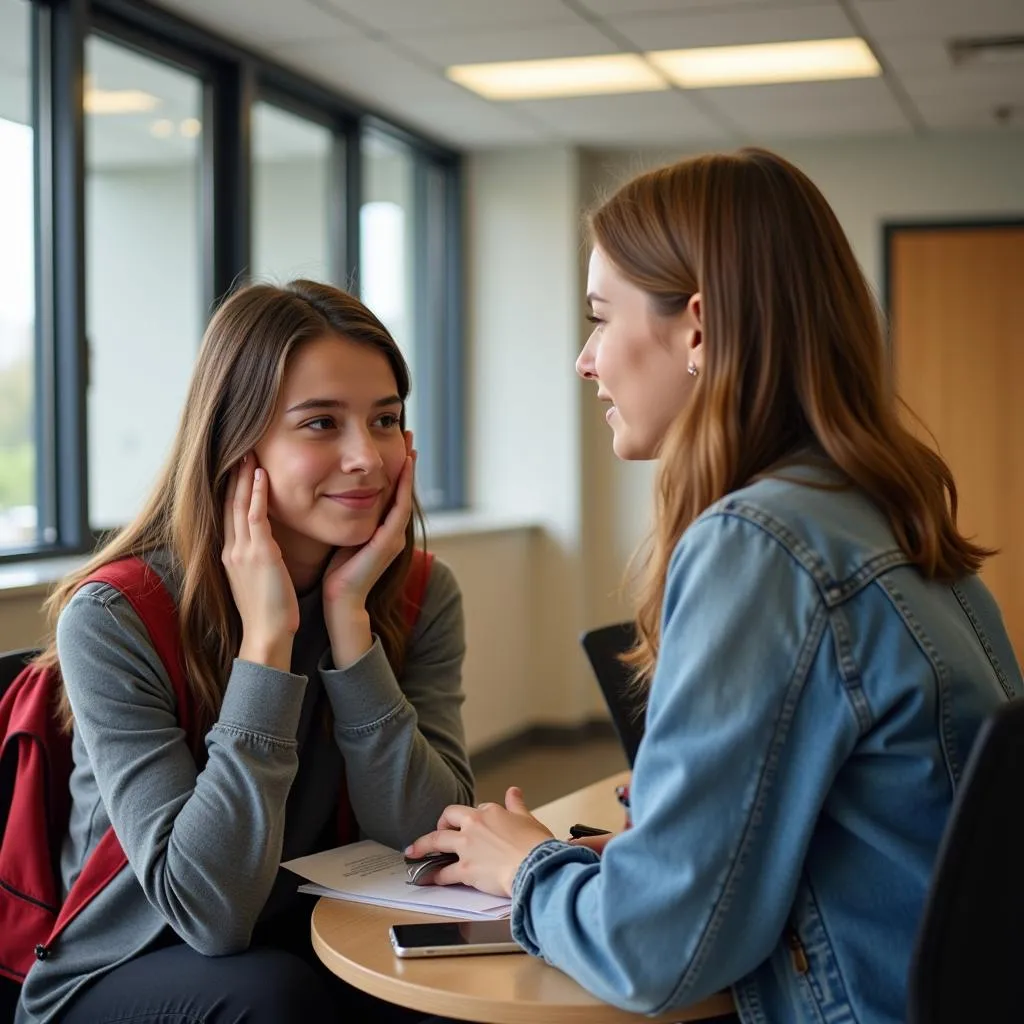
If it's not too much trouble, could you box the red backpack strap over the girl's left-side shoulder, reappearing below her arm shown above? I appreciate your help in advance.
[44,558,196,955]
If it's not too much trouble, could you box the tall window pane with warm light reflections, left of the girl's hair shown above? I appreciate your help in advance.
[85,37,205,529]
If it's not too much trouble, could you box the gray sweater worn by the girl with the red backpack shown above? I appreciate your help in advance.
[15,557,473,1024]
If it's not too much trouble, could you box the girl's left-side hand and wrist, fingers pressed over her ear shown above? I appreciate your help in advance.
[221,453,299,672]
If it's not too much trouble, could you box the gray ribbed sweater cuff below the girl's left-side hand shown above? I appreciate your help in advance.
[217,658,307,743]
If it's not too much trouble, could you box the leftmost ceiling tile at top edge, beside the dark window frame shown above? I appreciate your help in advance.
[149,0,358,47]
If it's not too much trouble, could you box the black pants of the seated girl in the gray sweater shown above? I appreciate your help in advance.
[60,899,432,1024]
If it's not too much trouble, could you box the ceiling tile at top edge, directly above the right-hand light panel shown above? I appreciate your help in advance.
[607,3,854,50]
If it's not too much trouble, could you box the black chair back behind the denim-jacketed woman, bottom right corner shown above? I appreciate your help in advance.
[908,699,1024,1024]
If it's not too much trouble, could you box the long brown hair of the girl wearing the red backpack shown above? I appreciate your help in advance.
[38,281,423,734]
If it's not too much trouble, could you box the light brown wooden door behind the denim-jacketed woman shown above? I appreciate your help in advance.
[889,225,1024,663]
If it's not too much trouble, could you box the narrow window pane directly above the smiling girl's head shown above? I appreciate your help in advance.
[252,102,335,284]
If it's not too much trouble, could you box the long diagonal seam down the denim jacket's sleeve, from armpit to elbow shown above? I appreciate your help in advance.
[655,603,828,1013]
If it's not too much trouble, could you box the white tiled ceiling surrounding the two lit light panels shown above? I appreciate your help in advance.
[155,0,1024,146]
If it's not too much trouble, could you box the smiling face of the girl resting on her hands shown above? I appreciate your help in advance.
[256,335,411,568]
